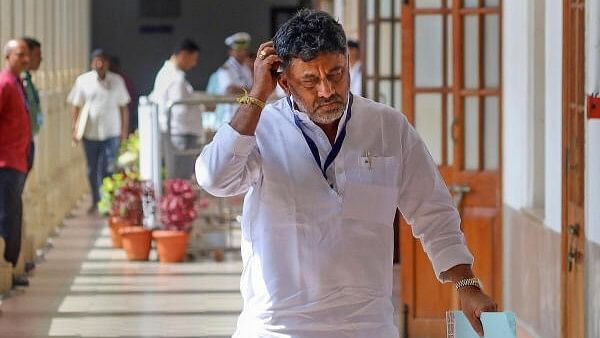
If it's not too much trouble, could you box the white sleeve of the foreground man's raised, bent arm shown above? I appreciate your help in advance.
[196,124,261,197]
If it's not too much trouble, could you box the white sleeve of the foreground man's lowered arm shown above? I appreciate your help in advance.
[398,121,473,281]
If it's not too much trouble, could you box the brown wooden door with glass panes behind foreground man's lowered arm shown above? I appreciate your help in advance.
[400,0,502,337]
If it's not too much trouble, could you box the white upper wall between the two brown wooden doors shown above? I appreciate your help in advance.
[503,0,562,232]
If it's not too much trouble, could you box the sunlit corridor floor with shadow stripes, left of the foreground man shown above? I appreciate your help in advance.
[0,198,242,338]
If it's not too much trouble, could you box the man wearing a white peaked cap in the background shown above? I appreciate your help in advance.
[208,32,252,127]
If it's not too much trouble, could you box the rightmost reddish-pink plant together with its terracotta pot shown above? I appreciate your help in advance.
[152,179,197,262]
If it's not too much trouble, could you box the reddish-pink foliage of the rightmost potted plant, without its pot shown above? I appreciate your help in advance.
[158,179,198,231]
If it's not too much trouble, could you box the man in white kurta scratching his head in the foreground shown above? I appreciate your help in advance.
[196,10,496,338]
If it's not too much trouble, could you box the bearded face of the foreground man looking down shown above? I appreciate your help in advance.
[279,53,350,124]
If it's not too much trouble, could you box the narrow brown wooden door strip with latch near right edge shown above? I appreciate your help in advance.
[561,0,585,338]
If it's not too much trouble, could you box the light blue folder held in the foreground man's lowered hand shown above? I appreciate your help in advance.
[446,311,517,338]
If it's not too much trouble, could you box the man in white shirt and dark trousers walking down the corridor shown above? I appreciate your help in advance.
[67,49,131,213]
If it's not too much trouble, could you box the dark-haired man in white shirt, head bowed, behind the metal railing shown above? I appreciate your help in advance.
[150,39,203,179]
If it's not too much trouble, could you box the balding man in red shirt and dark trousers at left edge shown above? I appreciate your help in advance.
[0,40,31,286]
